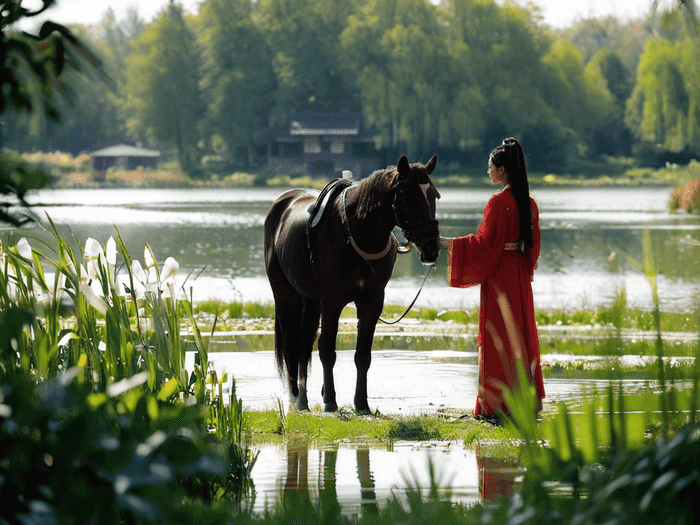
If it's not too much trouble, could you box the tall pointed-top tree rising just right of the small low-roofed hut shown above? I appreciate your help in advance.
[126,0,203,174]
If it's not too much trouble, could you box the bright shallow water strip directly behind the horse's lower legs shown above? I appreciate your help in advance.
[185,349,672,415]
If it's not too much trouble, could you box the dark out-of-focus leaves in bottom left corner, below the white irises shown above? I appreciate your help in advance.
[0,356,237,524]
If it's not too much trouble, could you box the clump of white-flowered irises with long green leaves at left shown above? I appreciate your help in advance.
[0,218,255,506]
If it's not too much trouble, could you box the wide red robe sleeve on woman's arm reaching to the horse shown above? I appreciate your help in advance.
[447,194,508,288]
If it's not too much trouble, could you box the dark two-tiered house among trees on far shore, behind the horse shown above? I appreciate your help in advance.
[255,111,379,178]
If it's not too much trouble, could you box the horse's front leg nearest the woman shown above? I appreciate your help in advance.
[355,293,384,414]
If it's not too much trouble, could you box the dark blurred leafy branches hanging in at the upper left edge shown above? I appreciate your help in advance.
[0,0,100,225]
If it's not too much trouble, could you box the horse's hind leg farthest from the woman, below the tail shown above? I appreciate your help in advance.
[273,283,309,410]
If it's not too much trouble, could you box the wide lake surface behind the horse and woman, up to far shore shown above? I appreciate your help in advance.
[3,187,700,310]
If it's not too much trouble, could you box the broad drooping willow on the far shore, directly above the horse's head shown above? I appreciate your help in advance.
[341,0,485,158]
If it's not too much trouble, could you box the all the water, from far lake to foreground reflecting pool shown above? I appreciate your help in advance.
[2,184,700,514]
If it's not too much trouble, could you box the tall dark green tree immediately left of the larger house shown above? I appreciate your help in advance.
[198,0,275,165]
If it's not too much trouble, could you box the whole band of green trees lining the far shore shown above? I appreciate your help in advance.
[3,0,700,173]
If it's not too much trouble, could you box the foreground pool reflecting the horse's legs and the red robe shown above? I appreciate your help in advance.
[250,439,524,515]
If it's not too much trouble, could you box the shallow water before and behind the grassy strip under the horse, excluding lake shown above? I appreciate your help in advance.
[194,349,676,515]
